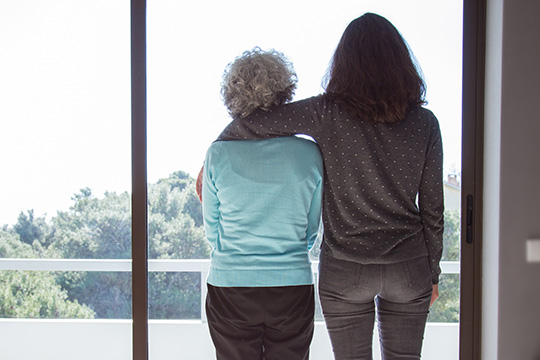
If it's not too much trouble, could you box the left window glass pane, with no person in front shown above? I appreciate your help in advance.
[0,0,131,360]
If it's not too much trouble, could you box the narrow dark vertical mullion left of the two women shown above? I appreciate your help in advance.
[131,0,148,360]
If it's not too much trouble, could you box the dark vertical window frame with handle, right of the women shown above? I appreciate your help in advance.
[459,0,486,360]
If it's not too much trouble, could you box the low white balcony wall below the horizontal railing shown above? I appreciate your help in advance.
[0,319,459,360]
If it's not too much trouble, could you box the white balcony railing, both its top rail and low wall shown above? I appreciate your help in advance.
[0,259,459,360]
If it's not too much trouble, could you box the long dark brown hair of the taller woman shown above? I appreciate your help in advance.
[325,13,426,122]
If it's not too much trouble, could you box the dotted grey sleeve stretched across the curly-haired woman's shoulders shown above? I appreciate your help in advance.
[218,96,327,140]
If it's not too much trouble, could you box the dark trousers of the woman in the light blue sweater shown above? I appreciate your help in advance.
[206,284,315,360]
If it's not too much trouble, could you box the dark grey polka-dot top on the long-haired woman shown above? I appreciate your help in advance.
[218,96,444,284]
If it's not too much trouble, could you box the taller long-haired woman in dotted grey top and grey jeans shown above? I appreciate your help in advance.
[211,13,443,360]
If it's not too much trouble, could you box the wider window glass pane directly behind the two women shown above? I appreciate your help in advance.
[148,0,462,360]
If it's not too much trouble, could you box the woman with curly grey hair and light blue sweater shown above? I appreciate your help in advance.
[202,49,323,360]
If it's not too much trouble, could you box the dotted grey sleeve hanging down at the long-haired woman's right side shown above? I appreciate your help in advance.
[418,115,444,284]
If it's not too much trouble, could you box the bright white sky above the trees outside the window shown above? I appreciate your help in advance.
[0,0,462,225]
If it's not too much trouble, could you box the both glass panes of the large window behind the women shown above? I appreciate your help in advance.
[0,0,482,360]
